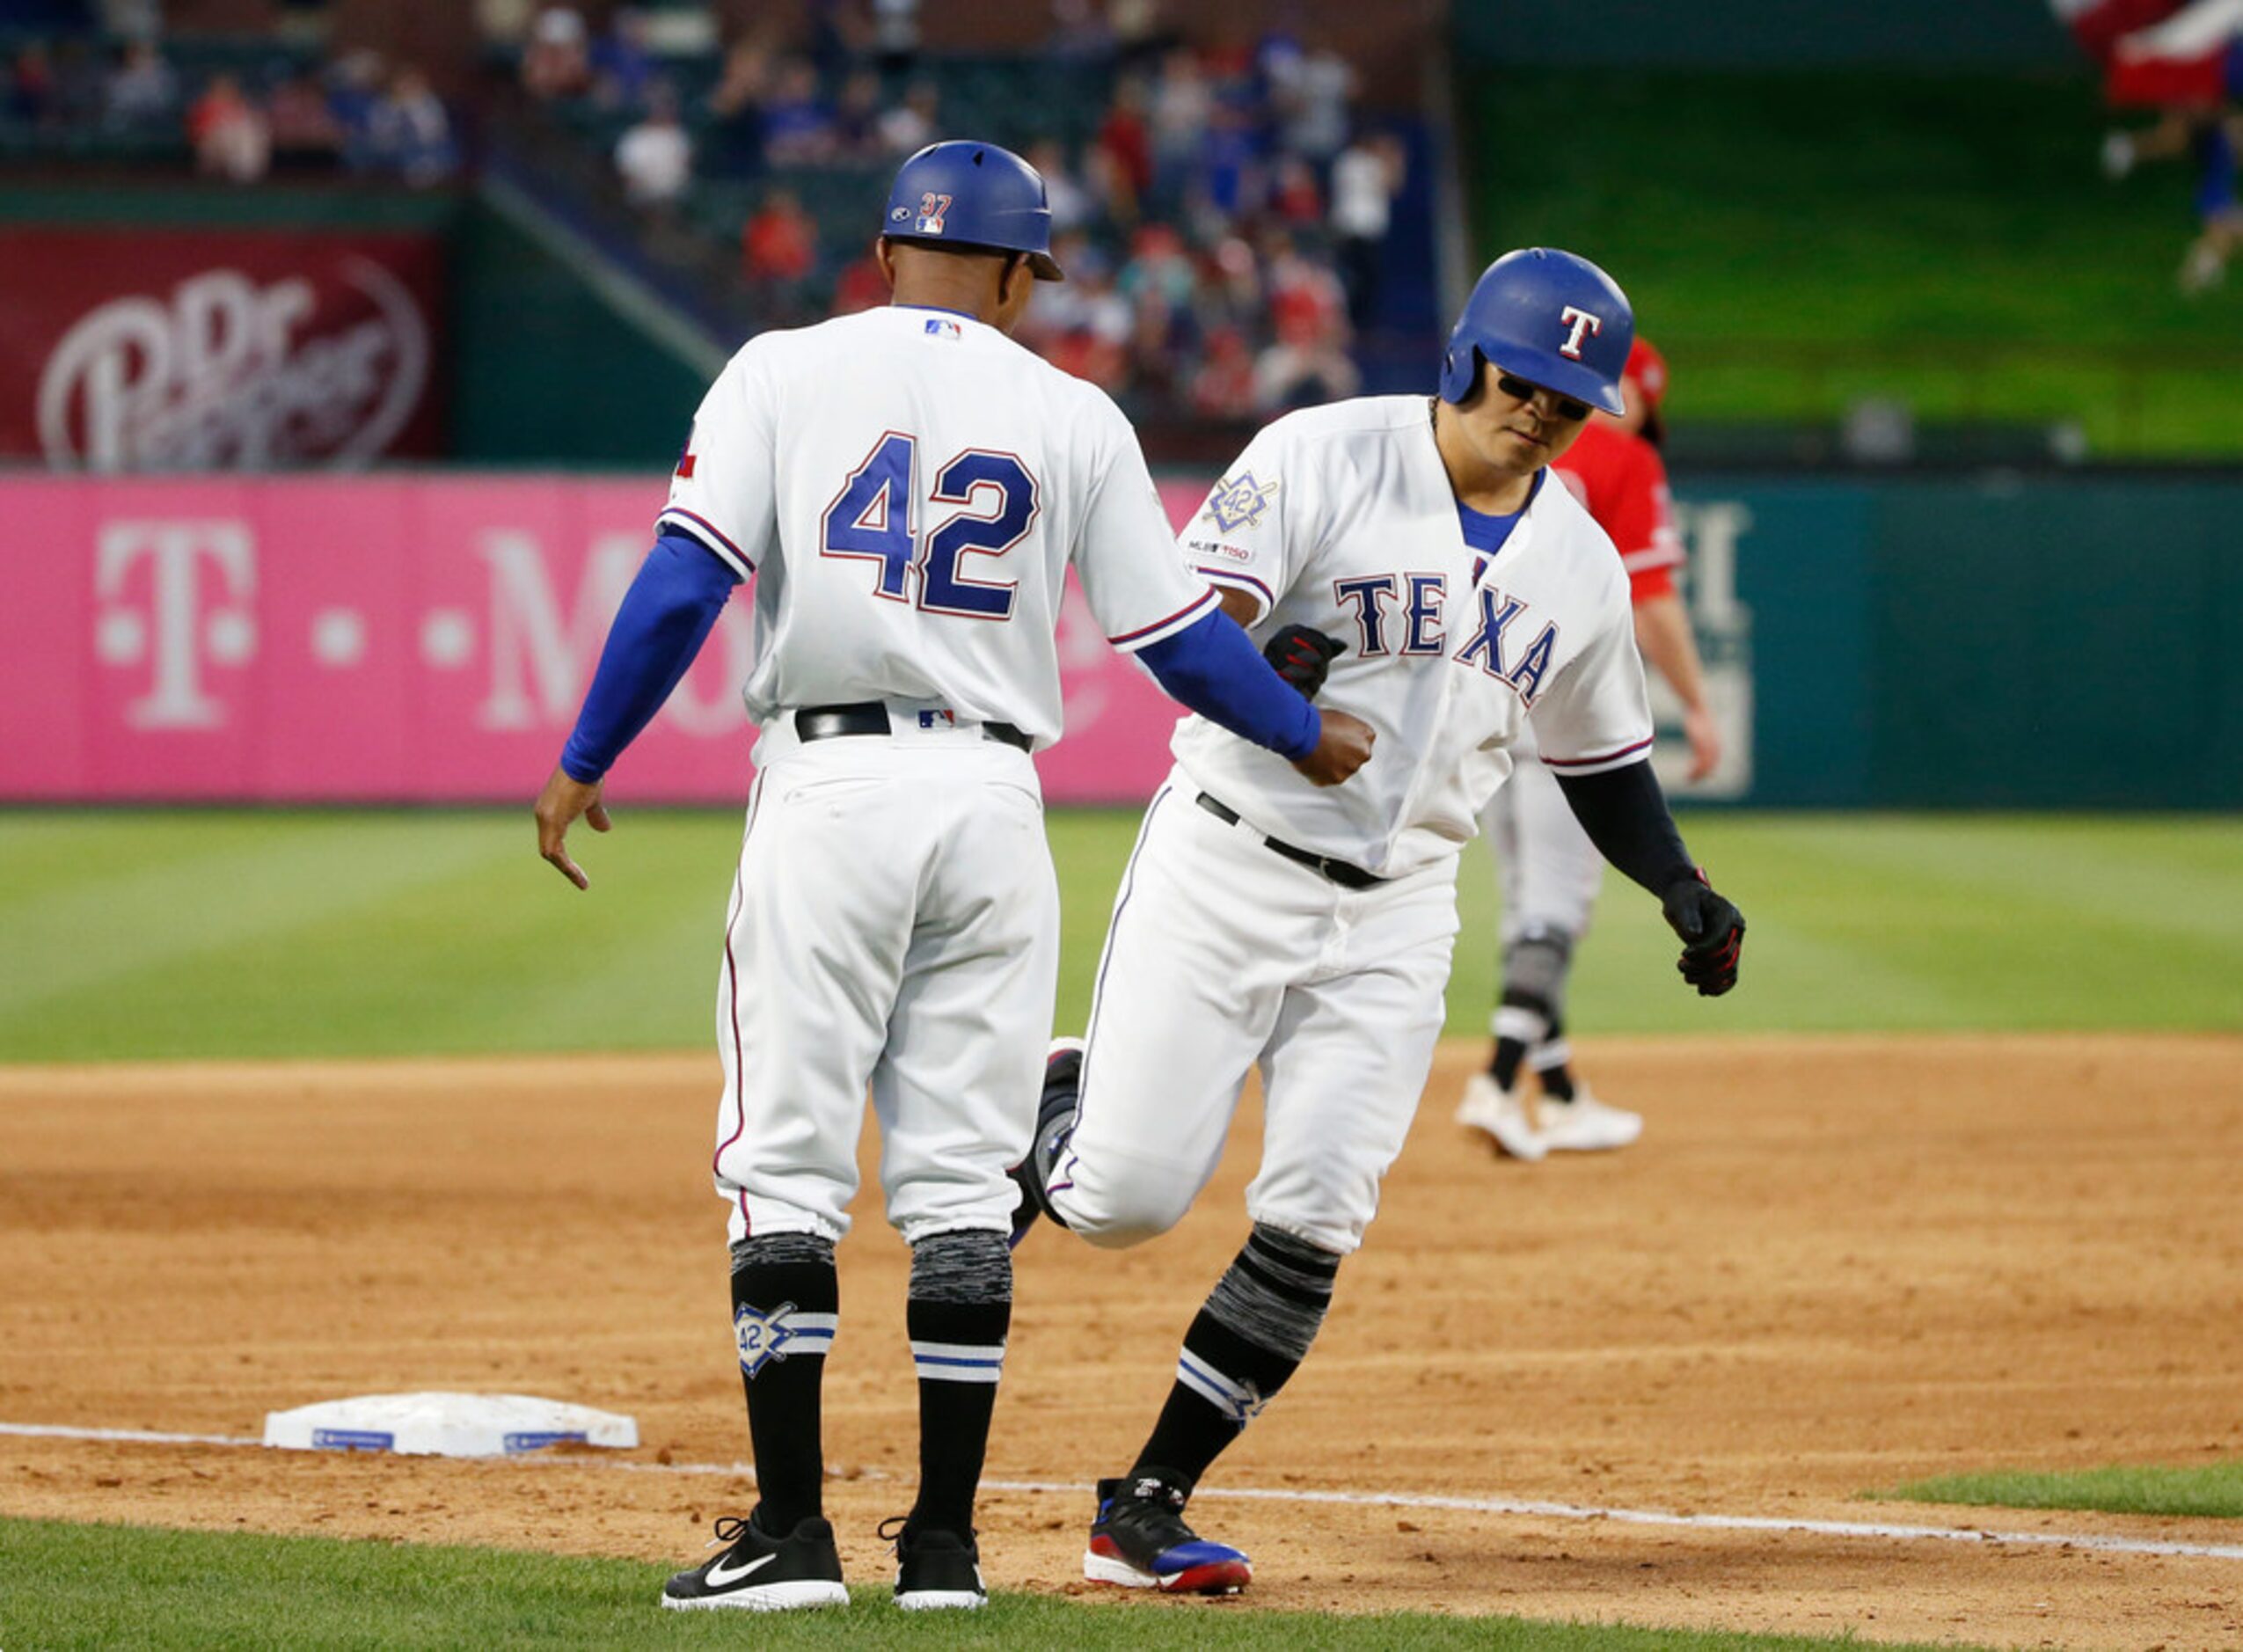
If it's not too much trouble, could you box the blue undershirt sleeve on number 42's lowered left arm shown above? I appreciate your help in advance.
[561,532,741,786]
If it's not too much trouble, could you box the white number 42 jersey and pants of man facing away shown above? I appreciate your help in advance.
[661,308,1216,1239]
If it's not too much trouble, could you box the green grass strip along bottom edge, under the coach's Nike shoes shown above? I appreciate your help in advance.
[0,1519,2000,1652]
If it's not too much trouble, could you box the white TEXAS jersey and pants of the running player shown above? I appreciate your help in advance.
[1049,398,1651,1254]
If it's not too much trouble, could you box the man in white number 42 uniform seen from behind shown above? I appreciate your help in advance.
[538,142,1373,1610]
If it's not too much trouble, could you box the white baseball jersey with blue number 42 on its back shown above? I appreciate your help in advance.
[660,305,1216,748]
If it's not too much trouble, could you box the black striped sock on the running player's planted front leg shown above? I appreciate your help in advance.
[1130,1224,1339,1495]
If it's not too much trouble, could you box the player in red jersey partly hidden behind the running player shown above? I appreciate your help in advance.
[1456,339,1721,1163]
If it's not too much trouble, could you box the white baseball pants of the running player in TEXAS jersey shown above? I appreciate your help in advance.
[1049,770,1458,1254]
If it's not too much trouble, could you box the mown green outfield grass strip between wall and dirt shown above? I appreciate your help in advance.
[0,810,2243,1062]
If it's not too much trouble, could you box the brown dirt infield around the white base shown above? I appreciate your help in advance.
[0,1037,2243,1652]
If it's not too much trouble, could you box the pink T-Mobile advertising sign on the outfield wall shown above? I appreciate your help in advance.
[0,476,1200,803]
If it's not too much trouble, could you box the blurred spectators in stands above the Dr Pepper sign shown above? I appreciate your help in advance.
[0,0,460,186]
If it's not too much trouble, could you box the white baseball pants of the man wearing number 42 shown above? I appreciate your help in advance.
[715,713,1059,1241]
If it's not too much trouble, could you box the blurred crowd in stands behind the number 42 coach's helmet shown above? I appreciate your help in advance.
[495,0,1406,420]
